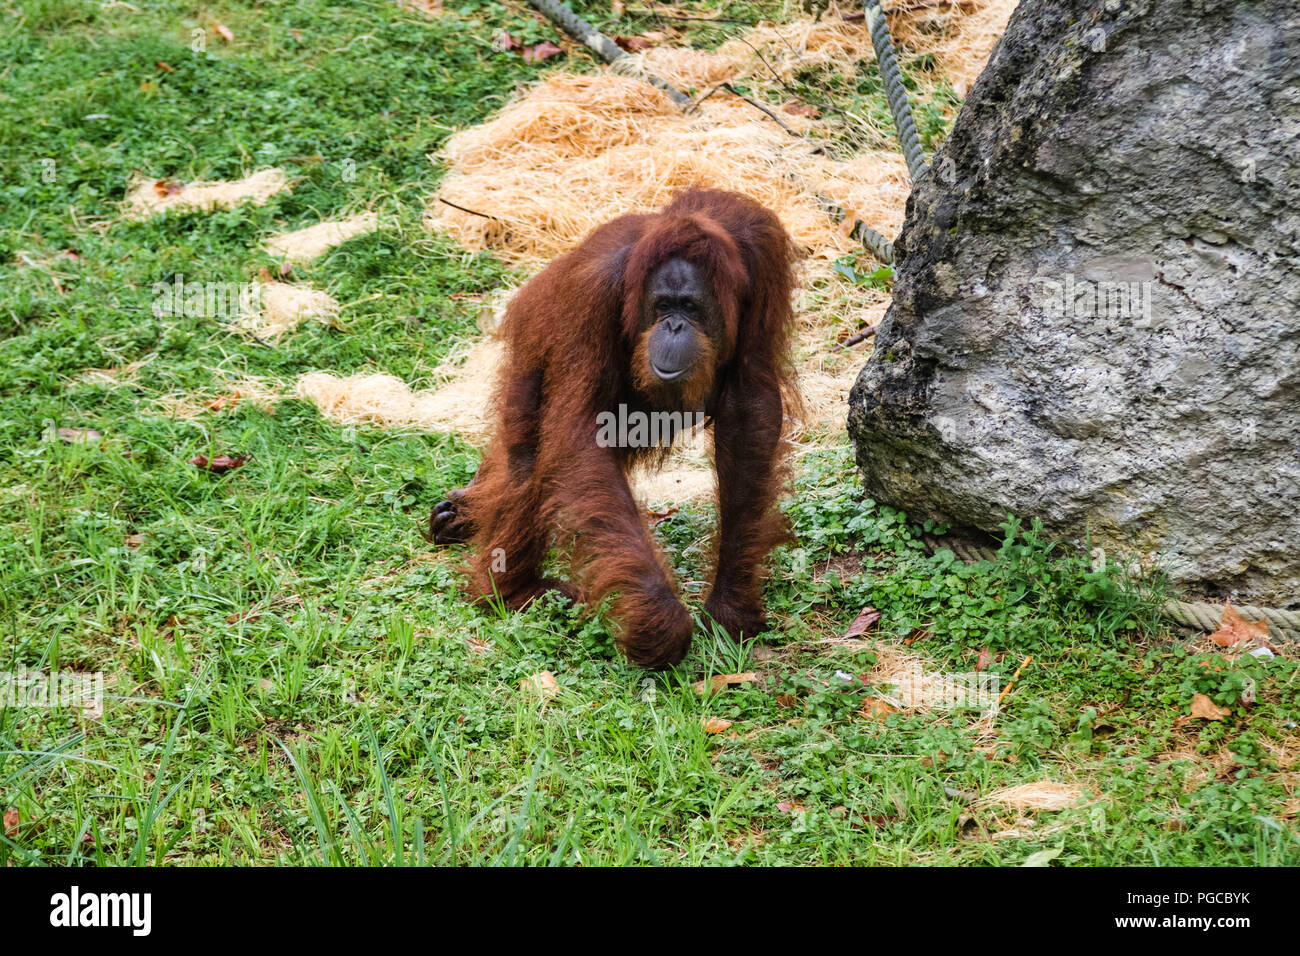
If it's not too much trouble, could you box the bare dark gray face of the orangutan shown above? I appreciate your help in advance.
[644,259,723,382]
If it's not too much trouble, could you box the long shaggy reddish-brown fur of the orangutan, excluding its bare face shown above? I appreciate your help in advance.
[436,190,798,667]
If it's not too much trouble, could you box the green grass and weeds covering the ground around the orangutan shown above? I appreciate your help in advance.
[0,0,1300,865]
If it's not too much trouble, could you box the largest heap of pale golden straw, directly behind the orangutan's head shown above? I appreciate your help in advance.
[426,74,907,265]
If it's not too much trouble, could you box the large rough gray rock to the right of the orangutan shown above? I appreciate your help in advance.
[849,0,1300,607]
